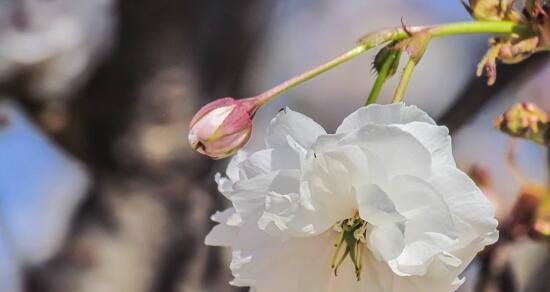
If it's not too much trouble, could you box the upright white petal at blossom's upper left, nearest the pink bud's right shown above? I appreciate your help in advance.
[265,108,326,151]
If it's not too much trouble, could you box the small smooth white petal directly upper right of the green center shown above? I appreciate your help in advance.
[355,184,406,225]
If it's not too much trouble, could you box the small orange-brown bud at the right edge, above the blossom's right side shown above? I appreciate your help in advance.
[495,102,550,144]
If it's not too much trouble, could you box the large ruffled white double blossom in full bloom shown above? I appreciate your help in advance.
[206,104,498,292]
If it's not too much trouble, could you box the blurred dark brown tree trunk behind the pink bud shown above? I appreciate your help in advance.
[24,0,273,292]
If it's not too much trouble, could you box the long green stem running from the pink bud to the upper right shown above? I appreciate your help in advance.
[256,21,532,104]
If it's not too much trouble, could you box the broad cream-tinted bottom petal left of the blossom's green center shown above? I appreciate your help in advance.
[231,229,336,292]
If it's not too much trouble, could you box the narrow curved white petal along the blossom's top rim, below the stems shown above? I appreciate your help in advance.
[336,103,435,134]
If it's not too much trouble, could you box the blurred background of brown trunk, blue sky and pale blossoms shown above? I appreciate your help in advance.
[0,0,550,292]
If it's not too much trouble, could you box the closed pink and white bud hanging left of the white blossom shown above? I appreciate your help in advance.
[189,97,260,159]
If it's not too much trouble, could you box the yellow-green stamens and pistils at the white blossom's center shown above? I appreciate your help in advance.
[331,212,367,281]
